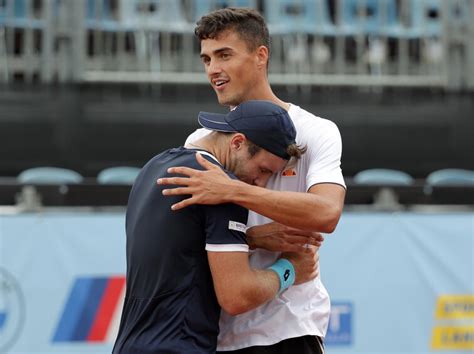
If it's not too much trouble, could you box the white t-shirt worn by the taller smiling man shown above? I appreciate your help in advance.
[186,105,345,351]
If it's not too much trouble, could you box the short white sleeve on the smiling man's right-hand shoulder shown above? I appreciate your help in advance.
[306,121,346,190]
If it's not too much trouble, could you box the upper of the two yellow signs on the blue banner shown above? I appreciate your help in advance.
[436,295,474,320]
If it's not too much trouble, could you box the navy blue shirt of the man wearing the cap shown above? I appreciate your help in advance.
[113,147,248,354]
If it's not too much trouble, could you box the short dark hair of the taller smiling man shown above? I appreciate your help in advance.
[194,7,270,53]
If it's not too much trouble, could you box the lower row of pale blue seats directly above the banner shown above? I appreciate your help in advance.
[0,166,474,210]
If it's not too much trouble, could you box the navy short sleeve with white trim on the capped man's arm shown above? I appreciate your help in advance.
[206,203,249,252]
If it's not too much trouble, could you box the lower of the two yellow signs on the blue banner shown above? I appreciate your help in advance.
[431,326,474,350]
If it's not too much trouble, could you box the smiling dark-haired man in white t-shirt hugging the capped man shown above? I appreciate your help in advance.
[158,8,345,354]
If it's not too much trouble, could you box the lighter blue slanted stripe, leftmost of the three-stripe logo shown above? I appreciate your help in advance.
[53,278,94,342]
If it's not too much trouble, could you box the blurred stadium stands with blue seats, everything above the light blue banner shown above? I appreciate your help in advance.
[0,0,474,206]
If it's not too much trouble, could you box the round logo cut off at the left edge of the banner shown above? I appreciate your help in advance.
[0,268,25,353]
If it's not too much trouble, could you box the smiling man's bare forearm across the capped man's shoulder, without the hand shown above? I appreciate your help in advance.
[226,181,342,233]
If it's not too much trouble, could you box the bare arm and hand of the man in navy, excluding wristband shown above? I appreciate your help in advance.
[207,248,319,315]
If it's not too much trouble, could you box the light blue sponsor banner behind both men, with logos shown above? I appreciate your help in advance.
[0,212,474,354]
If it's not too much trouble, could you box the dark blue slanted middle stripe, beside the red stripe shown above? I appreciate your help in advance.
[72,278,108,341]
